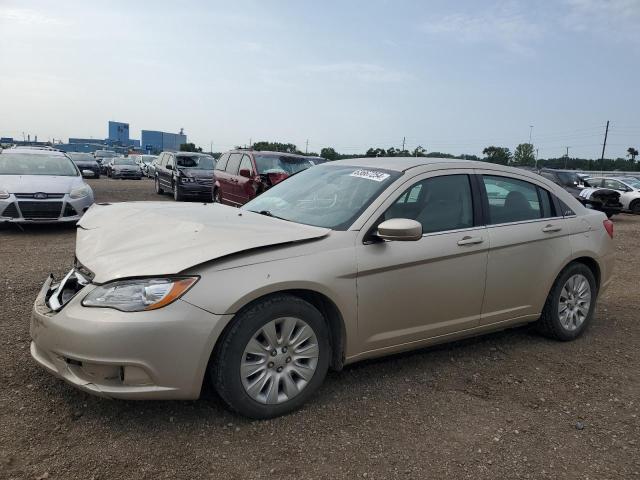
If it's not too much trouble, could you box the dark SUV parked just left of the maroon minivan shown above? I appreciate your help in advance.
[154,152,216,202]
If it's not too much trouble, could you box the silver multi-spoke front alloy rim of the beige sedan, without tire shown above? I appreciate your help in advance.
[240,317,320,405]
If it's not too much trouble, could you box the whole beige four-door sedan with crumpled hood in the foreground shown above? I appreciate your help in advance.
[31,158,614,418]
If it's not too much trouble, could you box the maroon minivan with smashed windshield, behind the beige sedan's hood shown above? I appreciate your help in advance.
[213,150,325,207]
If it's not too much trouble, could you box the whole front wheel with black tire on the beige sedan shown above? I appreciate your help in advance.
[209,295,330,419]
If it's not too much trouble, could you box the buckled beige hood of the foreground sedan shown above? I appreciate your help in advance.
[76,202,329,283]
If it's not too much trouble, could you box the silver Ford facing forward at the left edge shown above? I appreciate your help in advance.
[0,148,93,223]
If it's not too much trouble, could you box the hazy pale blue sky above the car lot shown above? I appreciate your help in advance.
[0,0,640,158]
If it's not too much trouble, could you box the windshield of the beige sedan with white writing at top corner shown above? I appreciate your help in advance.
[242,164,401,230]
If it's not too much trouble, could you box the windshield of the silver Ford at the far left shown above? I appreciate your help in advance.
[0,153,78,177]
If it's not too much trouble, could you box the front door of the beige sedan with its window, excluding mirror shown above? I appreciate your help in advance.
[356,170,489,351]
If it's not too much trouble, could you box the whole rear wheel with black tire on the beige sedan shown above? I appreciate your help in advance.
[537,263,598,341]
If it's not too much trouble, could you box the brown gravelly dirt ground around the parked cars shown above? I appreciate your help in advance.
[0,179,640,479]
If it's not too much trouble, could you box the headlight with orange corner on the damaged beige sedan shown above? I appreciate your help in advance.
[82,277,198,312]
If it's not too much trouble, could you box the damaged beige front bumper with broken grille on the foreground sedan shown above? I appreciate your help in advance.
[30,271,230,400]
